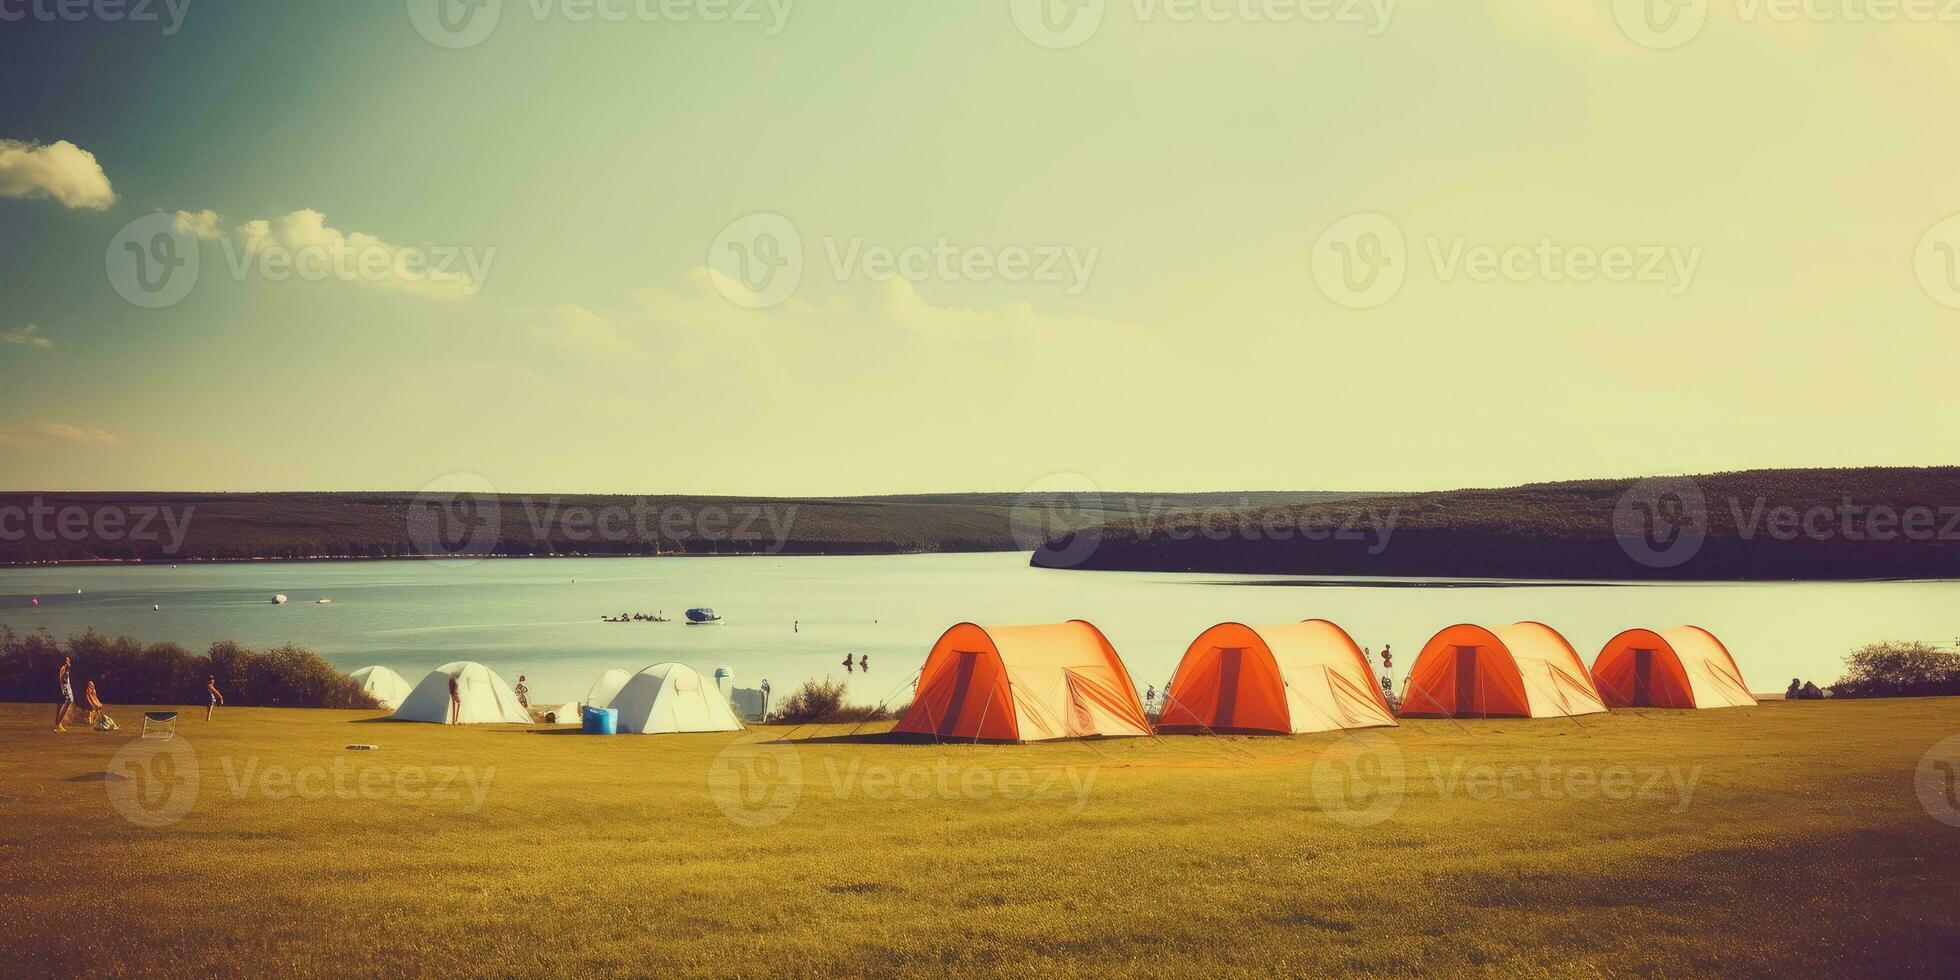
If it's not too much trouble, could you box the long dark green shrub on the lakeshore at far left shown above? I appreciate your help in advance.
[0,627,380,710]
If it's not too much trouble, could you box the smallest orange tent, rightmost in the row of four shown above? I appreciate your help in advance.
[1593,625,1756,708]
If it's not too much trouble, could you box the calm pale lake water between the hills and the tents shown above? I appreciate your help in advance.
[0,555,1960,704]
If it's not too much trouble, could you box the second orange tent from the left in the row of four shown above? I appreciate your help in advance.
[1156,619,1396,733]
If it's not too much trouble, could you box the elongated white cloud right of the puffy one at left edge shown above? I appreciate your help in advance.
[231,208,496,300]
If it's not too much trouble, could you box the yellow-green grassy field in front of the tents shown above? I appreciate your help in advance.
[0,700,1960,976]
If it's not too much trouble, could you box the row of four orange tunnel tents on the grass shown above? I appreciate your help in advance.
[894,619,1756,741]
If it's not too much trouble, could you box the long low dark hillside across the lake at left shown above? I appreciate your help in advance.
[0,492,1379,564]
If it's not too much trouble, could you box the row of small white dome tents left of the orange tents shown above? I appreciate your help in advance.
[380,662,743,735]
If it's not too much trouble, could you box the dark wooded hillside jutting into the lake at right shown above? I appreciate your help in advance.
[1035,466,1960,580]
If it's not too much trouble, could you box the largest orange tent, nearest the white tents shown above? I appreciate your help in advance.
[892,619,1151,741]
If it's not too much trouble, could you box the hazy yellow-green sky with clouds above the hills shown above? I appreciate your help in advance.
[0,0,1960,496]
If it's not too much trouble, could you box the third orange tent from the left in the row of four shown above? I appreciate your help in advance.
[1401,623,1605,717]
